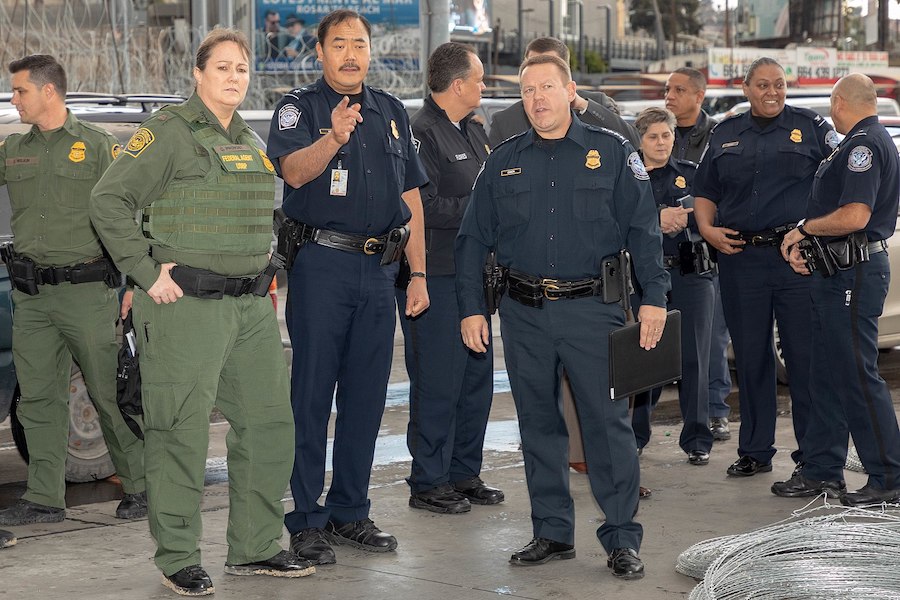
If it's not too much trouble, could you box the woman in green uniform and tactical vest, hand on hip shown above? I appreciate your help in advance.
[91,29,315,596]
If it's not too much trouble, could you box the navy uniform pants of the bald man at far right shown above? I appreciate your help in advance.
[803,252,900,489]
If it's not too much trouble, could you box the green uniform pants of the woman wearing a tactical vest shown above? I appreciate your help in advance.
[134,290,294,575]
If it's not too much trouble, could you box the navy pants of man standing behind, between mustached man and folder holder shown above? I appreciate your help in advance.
[397,275,494,493]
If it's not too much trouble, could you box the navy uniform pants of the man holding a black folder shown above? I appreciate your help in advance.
[500,297,643,552]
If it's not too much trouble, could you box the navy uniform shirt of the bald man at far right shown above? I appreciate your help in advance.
[807,116,900,241]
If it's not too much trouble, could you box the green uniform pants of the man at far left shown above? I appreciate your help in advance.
[13,282,144,508]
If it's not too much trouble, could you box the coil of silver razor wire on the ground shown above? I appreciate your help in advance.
[676,502,900,600]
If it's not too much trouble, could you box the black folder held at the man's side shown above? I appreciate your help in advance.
[609,310,681,400]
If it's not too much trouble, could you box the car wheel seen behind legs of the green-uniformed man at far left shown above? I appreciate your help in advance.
[10,364,116,483]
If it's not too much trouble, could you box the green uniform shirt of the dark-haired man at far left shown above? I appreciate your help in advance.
[0,112,120,267]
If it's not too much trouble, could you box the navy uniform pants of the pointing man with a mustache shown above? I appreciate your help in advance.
[285,244,398,533]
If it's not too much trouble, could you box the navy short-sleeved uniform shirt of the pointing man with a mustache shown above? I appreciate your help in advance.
[267,79,428,235]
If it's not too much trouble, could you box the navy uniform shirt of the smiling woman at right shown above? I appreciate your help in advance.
[694,105,838,231]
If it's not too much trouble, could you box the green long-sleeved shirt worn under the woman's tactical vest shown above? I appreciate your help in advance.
[91,93,275,290]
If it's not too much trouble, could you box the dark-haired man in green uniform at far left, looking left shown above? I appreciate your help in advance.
[0,55,147,525]
